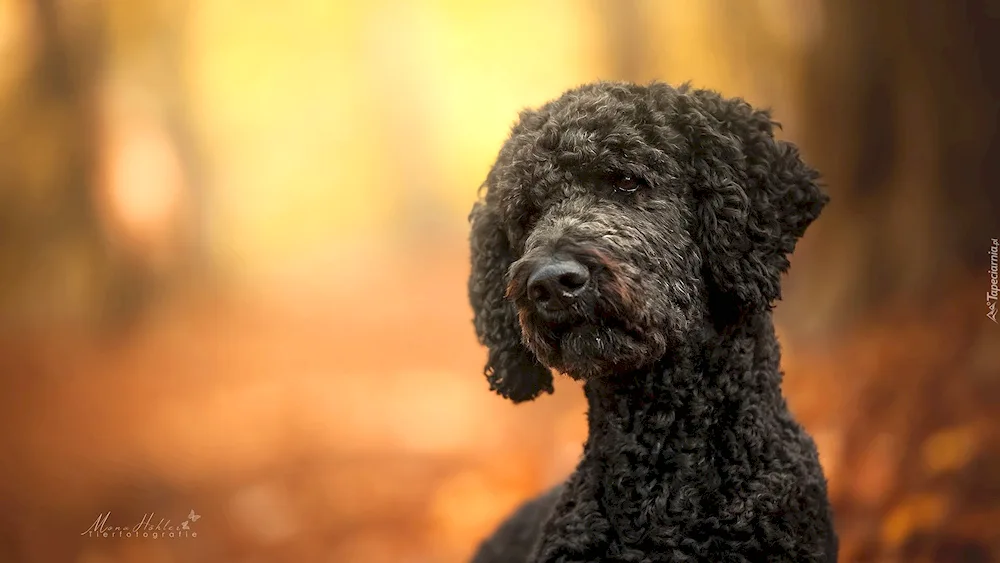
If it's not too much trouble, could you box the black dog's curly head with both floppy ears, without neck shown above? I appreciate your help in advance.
[469,83,827,401]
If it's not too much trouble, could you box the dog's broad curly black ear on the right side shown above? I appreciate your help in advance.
[678,86,829,315]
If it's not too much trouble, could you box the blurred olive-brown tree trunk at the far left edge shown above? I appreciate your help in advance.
[0,0,136,332]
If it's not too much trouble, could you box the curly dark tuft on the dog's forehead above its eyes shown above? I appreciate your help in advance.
[489,83,688,227]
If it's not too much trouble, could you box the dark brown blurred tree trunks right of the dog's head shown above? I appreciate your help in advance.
[796,0,1000,334]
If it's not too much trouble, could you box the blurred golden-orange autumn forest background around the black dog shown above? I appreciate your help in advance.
[0,0,1000,563]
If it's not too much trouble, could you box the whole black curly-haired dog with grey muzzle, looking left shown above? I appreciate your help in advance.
[469,82,837,563]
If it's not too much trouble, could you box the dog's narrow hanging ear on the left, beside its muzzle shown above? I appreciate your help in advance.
[469,187,552,403]
